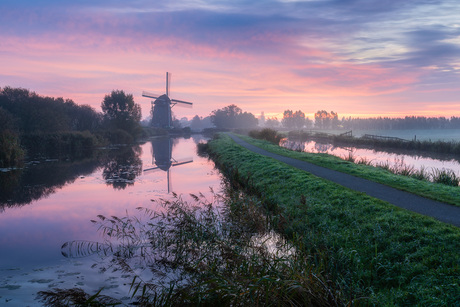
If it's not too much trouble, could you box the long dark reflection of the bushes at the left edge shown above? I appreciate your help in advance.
[0,159,99,211]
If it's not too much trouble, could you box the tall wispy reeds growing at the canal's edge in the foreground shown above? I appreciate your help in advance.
[45,183,344,306]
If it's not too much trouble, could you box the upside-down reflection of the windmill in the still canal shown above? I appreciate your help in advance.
[144,137,193,193]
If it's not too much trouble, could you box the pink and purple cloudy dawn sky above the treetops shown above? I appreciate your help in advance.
[0,0,460,119]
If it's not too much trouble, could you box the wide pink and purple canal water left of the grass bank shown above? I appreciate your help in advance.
[0,136,221,306]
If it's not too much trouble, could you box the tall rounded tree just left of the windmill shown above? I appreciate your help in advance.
[101,90,141,136]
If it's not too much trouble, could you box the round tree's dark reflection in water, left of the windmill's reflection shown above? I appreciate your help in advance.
[102,146,142,190]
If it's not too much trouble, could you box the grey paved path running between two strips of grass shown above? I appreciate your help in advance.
[228,134,460,227]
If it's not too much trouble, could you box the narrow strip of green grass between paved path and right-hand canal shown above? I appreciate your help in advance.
[239,135,460,206]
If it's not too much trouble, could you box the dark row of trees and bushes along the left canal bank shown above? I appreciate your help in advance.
[0,87,142,167]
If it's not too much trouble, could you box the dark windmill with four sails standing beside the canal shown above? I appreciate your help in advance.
[142,72,193,128]
